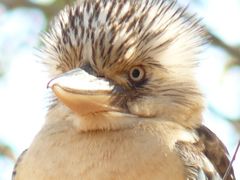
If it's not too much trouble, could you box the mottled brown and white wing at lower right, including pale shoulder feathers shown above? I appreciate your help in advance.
[175,126,236,180]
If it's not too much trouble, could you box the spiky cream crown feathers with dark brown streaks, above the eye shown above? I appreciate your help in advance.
[39,0,204,76]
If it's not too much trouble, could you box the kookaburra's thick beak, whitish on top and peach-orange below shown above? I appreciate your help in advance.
[48,68,117,116]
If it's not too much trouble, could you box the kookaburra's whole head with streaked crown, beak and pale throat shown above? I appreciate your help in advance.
[40,0,204,130]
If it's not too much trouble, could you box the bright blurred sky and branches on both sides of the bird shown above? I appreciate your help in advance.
[0,0,240,180]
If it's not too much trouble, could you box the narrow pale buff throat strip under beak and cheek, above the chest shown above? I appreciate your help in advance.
[46,103,202,131]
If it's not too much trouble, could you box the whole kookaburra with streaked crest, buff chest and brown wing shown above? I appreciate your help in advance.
[13,0,235,180]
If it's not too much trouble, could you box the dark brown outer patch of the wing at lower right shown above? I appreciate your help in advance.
[197,126,236,180]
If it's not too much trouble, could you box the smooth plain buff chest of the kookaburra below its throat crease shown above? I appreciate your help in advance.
[16,124,184,180]
